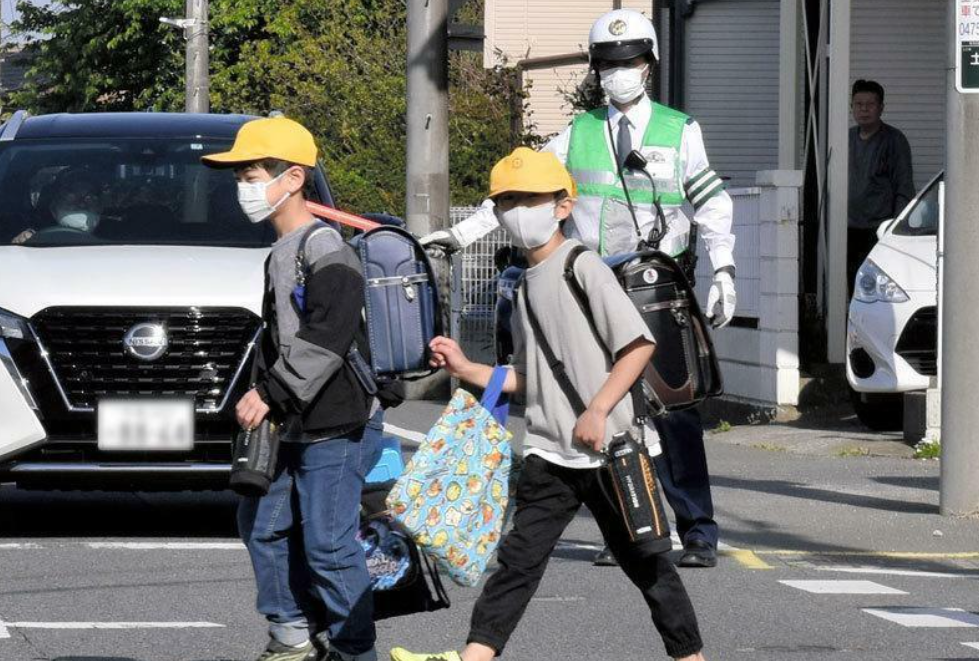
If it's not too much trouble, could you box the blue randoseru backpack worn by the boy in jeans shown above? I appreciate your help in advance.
[293,221,442,384]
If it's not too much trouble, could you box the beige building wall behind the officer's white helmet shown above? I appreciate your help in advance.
[483,0,652,136]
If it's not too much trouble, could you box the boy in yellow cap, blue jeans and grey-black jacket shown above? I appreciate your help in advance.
[203,117,381,661]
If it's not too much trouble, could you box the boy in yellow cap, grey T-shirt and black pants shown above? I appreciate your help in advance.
[391,148,704,661]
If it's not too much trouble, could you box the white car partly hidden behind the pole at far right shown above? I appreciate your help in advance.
[846,173,943,430]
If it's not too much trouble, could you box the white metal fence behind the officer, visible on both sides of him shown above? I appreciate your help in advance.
[450,188,761,364]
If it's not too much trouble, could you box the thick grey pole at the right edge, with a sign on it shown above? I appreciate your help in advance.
[941,0,979,516]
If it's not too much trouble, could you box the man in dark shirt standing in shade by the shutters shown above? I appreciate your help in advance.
[847,80,914,291]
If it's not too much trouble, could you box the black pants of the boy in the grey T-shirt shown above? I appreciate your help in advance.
[468,455,703,657]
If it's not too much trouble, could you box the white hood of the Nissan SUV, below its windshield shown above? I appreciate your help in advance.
[0,246,268,318]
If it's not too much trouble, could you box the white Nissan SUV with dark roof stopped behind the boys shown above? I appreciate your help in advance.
[0,112,333,489]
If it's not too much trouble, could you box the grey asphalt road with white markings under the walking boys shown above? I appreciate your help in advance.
[0,411,979,661]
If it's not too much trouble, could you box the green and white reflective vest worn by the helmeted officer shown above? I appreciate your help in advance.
[567,103,688,255]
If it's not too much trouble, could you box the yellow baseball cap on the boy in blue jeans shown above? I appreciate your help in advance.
[201,117,316,168]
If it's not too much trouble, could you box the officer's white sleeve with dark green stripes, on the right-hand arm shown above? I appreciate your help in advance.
[680,120,734,271]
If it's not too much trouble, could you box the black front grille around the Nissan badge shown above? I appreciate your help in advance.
[32,307,261,411]
